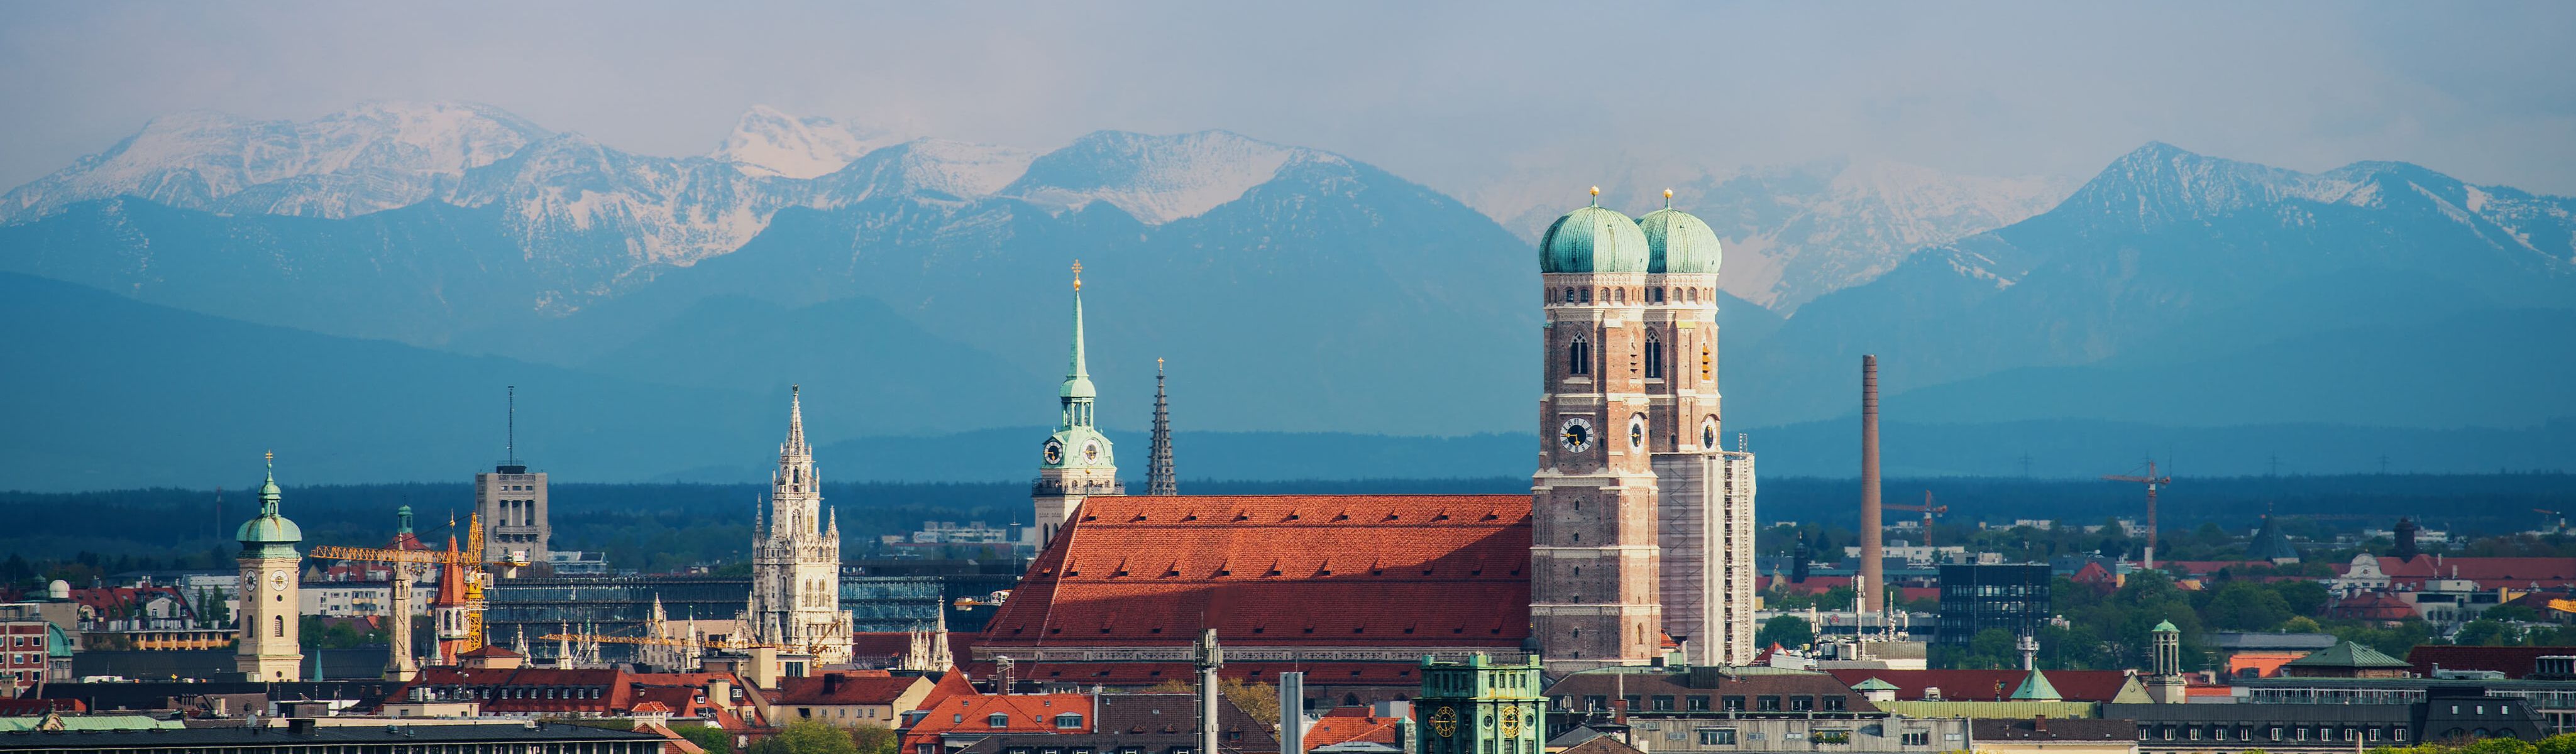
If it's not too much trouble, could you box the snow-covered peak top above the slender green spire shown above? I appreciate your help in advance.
[1002,131,1308,224]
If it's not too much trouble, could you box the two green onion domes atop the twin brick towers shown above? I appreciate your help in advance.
[1538,188,1724,275]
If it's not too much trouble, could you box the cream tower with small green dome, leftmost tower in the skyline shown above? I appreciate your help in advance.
[232,453,304,682]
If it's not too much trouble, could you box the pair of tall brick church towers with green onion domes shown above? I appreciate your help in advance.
[1530,190,1754,672]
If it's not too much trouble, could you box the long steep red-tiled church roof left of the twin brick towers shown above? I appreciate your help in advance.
[981,494,1530,646]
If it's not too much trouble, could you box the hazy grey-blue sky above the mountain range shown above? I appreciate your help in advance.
[0,3,2576,193]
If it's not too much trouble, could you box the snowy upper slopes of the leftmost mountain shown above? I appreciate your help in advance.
[0,103,546,224]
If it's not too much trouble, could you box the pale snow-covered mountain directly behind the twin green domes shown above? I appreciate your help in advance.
[1476,160,2074,314]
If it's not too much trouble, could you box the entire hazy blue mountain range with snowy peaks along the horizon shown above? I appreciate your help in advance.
[0,103,2576,489]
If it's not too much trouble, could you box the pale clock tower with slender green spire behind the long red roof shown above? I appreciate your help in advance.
[1030,263,1126,550]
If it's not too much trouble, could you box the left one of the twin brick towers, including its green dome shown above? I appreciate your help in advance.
[1530,188,1672,672]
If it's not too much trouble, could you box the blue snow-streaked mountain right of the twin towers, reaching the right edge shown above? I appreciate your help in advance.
[1729,144,2576,420]
